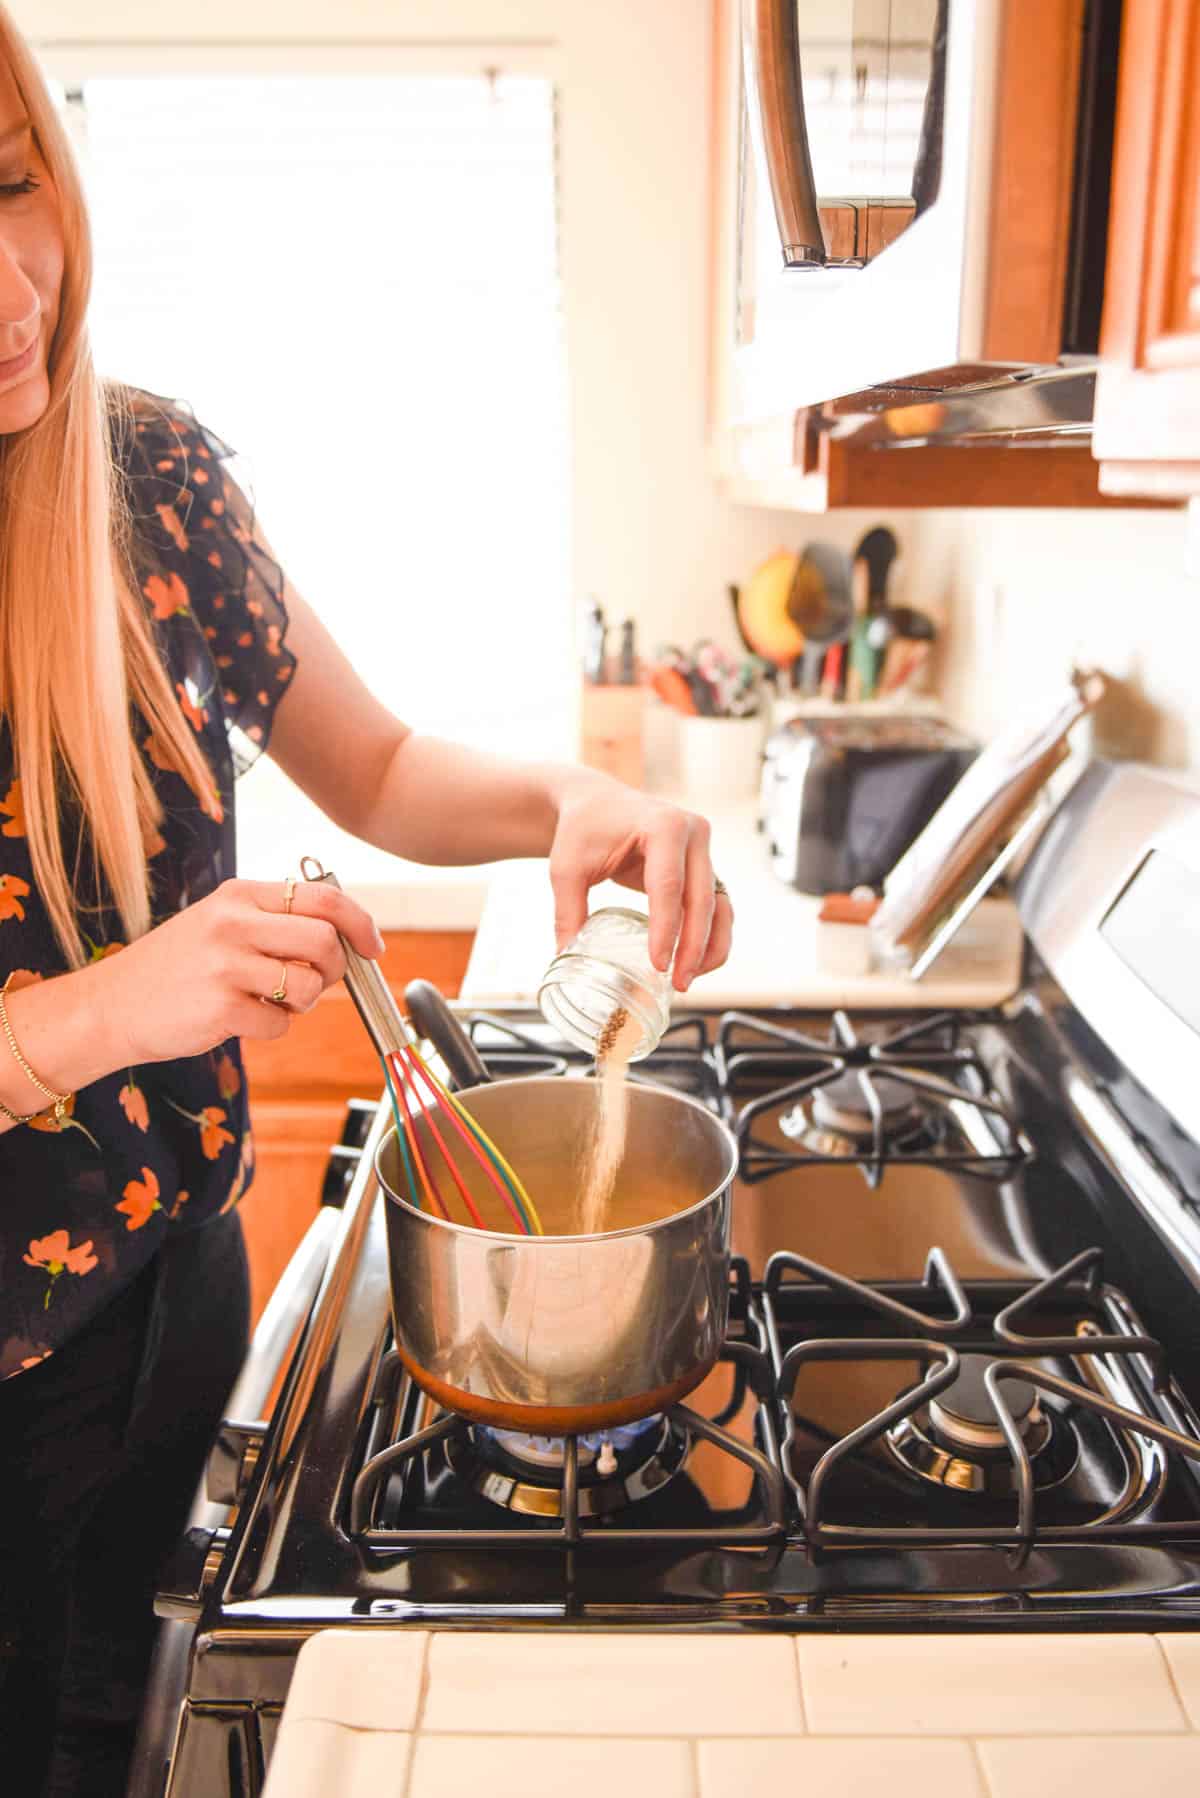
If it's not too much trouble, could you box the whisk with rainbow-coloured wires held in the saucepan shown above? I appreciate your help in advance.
[300,856,543,1235]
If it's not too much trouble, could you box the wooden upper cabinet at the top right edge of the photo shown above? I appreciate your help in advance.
[1092,0,1200,498]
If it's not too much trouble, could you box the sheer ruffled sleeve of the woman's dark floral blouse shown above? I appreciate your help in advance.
[127,403,295,773]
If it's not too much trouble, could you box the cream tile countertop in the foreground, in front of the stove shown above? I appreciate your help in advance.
[264,1627,1200,1798]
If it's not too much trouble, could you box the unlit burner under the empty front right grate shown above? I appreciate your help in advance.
[887,1354,1078,1496]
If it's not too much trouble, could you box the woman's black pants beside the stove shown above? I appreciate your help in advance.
[0,1212,248,1798]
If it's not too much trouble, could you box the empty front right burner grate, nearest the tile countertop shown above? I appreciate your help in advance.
[761,1248,1200,1568]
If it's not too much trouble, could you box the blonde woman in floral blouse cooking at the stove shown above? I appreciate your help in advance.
[0,11,730,1793]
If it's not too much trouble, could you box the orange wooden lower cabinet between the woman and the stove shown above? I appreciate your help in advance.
[233,930,473,1320]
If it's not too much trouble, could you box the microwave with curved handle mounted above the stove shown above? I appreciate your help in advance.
[723,0,1088,421]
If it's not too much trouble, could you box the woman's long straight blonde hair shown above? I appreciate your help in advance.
[0,5,214,967]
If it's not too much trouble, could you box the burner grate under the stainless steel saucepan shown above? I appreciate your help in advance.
[349,1257,788,1552]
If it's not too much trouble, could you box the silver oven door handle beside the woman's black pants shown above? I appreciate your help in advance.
[205,1205,342,1505]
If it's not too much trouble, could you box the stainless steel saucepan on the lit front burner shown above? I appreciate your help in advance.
[376,985,738,1437]
